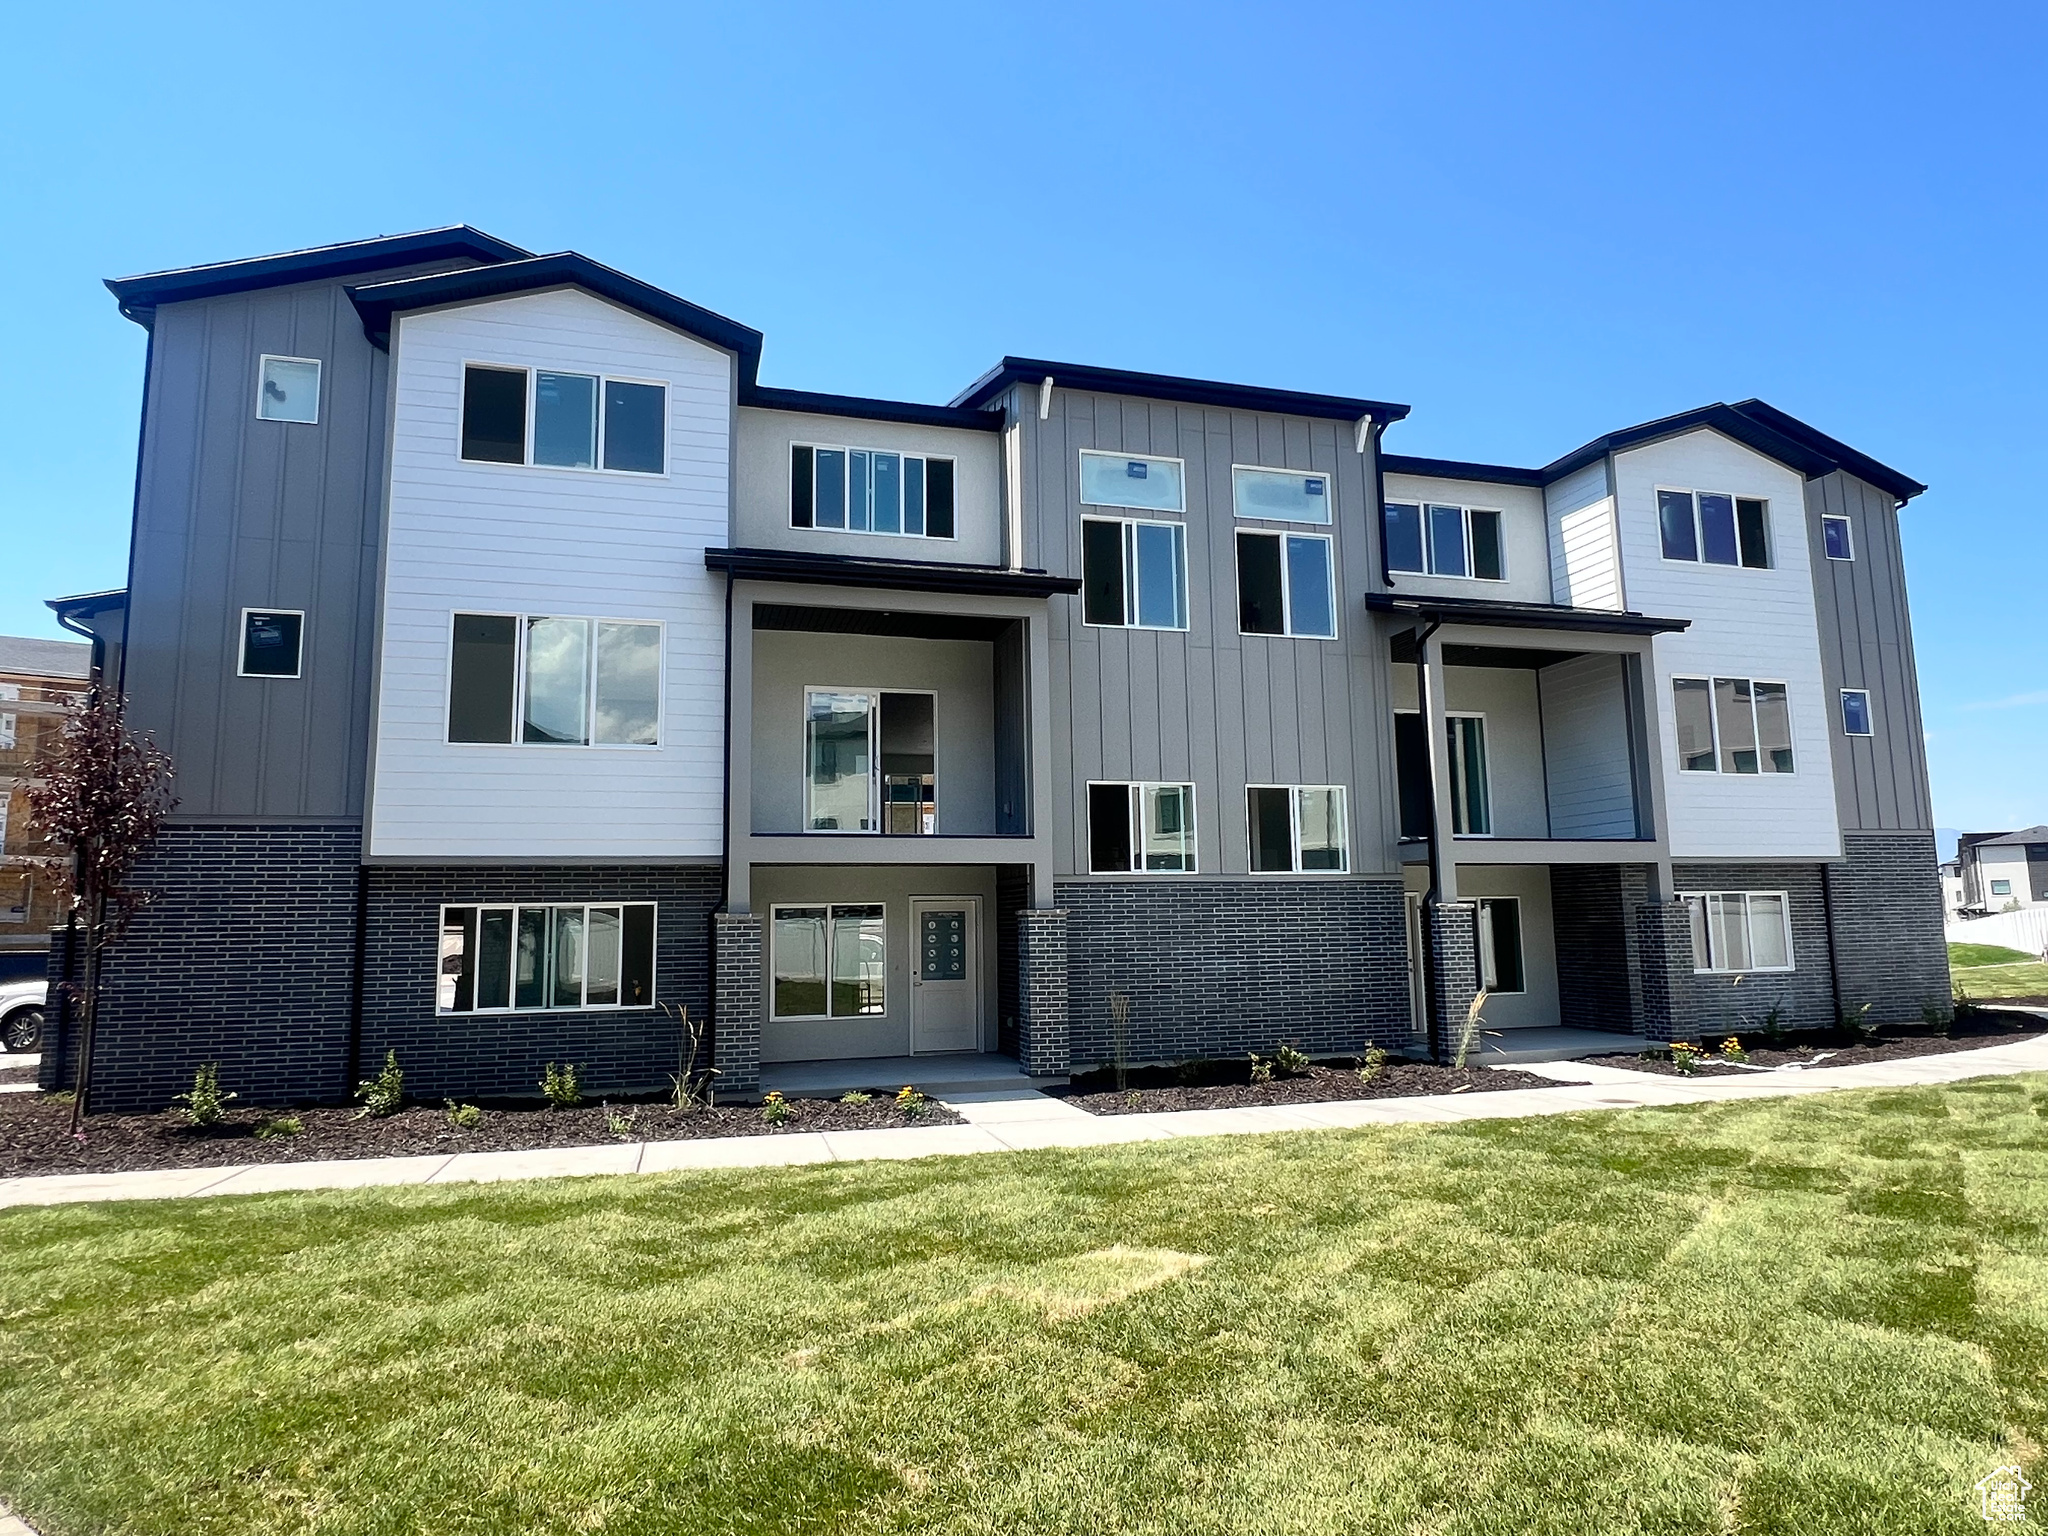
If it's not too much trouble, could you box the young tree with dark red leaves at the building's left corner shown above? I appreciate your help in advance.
[29,688,178,1137]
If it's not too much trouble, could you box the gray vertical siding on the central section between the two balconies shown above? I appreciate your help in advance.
[1008,385,1397,879]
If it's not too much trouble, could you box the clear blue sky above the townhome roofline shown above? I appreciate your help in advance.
[0,0,2048,827]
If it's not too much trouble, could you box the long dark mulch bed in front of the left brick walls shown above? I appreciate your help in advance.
[0,1094,958,1178]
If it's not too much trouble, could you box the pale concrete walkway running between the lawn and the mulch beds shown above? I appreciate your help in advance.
[0,1036,2048,1206]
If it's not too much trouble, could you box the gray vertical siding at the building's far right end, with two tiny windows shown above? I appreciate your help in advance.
[1806,469,1933,831]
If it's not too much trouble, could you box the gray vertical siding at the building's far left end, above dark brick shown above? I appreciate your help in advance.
[123,260,491,821]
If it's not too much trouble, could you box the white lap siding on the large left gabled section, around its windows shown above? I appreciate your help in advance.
[369,291,733,860]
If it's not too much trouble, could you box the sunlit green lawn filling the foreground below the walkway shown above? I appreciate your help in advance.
[0,1075,2048,1536]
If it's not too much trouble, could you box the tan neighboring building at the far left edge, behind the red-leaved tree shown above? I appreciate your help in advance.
[0,635,92,975]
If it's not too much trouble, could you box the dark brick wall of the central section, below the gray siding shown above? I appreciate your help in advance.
[1055,879,1411,1071]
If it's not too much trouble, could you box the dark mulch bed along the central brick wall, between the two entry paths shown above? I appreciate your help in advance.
[1044,1059,1559,1114]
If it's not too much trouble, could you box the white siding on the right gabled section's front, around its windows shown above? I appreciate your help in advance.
[1614,428,1841,858]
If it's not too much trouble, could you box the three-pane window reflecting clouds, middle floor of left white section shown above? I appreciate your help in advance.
[449,612,662,748]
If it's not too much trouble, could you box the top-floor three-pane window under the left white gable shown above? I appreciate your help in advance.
[463,362,668,475]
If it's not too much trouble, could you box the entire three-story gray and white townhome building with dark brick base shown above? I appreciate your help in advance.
[45,227,1948,1106]
